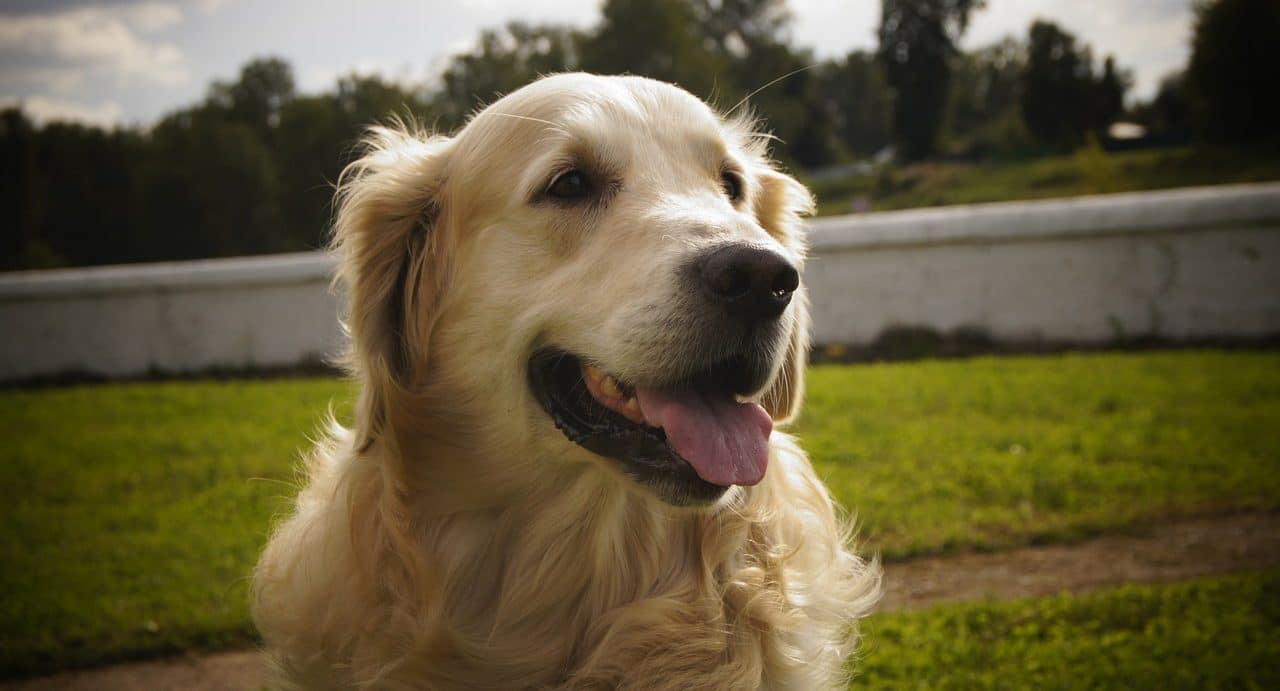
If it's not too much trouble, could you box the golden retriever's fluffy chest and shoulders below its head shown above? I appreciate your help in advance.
[255,434,878,690]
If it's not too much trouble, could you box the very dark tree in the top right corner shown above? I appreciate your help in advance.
[1187,0,1280,141]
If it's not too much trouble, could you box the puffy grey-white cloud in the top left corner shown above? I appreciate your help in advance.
[0,3,189,93]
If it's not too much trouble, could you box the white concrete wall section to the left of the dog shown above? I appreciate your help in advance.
[0,252,340,380]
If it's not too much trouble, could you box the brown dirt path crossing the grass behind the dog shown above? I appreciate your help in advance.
[10,513,1280,691]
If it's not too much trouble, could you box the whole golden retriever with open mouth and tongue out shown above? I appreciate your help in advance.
[253,74,879,691]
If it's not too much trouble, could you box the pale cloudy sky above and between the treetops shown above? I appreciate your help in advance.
[0,0,1192,124]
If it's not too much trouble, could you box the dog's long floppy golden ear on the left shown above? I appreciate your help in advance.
[330,127,449,448]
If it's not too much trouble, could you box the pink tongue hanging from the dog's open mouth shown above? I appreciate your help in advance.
[636,386,773,486]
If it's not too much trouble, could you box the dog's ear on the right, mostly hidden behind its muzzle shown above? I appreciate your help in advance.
[754,169,814,424]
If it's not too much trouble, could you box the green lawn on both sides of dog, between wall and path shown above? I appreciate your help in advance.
[0,352,1280,674]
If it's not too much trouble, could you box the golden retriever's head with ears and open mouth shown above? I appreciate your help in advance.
[335,74,813,504]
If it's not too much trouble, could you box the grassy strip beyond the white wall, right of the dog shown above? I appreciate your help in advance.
[806,143,1280,215]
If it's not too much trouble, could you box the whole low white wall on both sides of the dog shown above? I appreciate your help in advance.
[0,183,1280,380]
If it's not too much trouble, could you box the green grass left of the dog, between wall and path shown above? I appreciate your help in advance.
[0,380,349,673]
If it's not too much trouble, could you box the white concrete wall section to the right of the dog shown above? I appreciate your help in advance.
[805,183,1280,344]
